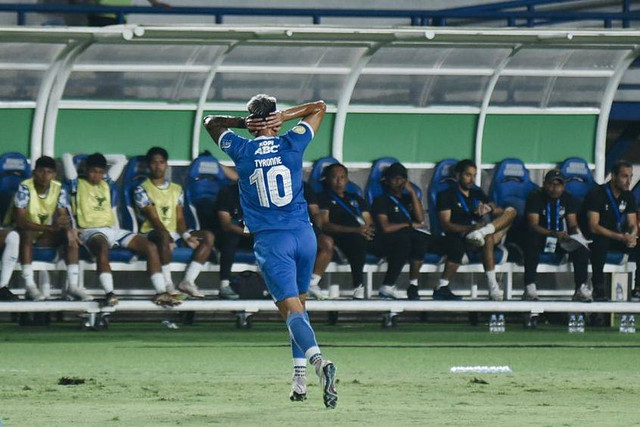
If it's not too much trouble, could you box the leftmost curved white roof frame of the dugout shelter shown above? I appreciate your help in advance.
[30,41,82,164]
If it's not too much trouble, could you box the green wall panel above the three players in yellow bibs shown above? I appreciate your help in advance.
[55,109,193,160]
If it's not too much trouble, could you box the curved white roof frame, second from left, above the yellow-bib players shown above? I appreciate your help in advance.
[42,40,92,157]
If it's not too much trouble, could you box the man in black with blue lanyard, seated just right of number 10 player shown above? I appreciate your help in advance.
[318,163,375,299]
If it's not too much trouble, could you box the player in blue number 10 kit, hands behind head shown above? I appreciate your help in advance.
[204,95,338,408]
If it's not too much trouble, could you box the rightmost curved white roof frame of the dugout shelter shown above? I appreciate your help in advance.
[594,45,640,183]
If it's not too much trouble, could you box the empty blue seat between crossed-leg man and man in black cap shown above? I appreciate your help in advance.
[489,158,538,219]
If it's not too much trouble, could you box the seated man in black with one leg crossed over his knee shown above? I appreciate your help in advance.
[434,159,516,301]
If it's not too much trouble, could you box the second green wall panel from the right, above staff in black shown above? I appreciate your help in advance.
[344,113,478,162]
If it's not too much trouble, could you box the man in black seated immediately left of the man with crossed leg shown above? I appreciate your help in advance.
[372,163,464,300]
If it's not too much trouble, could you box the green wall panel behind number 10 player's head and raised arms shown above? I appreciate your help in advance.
[200,111,335,161]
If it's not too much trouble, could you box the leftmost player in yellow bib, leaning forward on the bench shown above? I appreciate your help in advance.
[13,156,84,301]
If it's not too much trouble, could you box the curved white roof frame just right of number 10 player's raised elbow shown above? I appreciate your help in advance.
[331,43,387,162]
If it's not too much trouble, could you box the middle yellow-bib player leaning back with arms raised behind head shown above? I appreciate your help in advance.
[65,153,180,306]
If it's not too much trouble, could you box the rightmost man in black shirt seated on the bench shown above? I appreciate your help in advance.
[582,160,640,300]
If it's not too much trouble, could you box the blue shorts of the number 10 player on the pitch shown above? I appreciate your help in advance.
[253,225,317,302]
